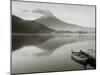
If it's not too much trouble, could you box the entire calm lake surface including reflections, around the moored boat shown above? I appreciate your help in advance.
[12,34,95,73]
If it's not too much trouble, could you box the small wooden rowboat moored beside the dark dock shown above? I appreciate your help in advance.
[71,51,88,69]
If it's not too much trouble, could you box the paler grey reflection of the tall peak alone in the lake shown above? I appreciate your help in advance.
[36,35,94,56]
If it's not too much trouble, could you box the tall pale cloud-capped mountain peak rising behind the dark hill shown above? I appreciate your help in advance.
[33,9,95,32]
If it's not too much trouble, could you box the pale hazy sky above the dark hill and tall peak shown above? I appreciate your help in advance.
[12,1,95,27]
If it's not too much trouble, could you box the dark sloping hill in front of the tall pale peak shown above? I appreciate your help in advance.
[12,15,54,33]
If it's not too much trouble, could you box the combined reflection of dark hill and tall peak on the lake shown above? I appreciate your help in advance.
[12,35,94,57]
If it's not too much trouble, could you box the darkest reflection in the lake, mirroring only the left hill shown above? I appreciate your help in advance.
[12,35,52,51]
